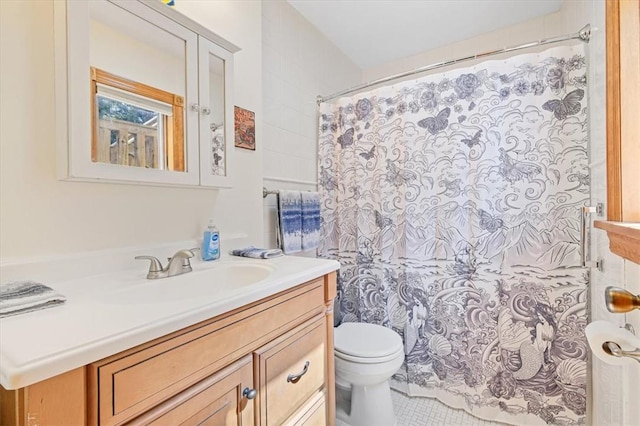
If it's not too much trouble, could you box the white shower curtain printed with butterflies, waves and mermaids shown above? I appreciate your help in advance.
[319,45,589,425]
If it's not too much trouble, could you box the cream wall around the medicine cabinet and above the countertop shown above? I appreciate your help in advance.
[0,0,263,260]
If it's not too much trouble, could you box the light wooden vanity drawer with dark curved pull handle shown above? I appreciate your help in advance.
[254,316,326,426]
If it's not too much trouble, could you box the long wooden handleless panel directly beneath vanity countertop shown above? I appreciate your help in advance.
[89,279,324,425]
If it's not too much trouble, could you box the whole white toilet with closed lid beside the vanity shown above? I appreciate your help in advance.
[333,322,404,426]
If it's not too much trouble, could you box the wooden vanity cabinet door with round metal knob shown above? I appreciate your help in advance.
[129,355,255,426]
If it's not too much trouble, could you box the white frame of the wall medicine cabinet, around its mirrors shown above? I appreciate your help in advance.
[53,0,240,188]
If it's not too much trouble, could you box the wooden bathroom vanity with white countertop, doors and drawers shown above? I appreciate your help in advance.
[0,257,338,425]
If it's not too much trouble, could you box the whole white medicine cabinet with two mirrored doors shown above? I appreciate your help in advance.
[54,0,239,188]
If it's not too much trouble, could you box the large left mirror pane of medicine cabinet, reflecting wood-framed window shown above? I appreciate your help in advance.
[89,2,186,171]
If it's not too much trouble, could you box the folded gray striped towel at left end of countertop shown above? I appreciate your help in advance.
[0,281,67,318]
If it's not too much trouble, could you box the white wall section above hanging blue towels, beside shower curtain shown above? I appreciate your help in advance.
[258,0,361,247]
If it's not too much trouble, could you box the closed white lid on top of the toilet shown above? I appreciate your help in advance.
[333,322,403,358]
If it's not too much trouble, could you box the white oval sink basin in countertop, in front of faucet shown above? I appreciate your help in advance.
[101,262,274,304]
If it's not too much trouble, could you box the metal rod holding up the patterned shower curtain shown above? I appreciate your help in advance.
[316,24,591,105]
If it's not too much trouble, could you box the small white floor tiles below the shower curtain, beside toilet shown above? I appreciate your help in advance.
[336,391,505,426]
